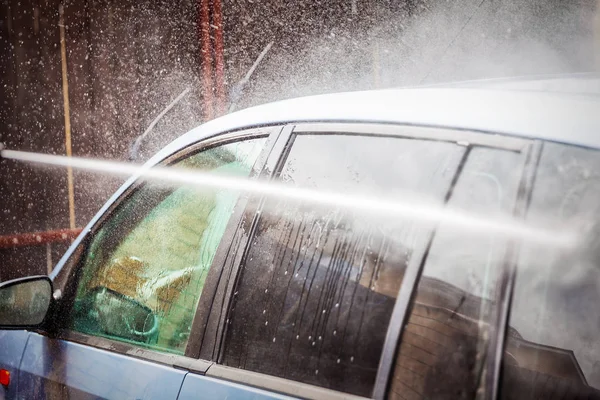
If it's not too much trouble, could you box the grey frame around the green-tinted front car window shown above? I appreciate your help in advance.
[45,125,283,373]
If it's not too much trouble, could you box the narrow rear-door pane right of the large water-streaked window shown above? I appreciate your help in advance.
[389,147,522,399]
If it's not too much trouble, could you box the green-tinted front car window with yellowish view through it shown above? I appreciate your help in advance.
[70,139,264,354]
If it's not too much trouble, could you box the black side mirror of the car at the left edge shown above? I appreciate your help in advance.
[0,276,52,329]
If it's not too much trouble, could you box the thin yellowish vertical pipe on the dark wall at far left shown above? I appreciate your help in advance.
[58,3,75,229]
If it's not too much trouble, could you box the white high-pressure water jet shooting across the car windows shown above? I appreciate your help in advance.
[0,149,580,251]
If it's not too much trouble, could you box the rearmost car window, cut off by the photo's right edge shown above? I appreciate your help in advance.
[501,143,600,399]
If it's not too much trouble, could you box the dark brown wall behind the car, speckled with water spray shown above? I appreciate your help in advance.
[0,0,600,280]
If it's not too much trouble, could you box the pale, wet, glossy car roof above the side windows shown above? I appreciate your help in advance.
[149,87,600,164]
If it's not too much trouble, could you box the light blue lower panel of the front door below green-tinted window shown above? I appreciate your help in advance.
[18,333,186,399]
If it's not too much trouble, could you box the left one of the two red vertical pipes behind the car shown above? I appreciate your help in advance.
[198,0,214,121]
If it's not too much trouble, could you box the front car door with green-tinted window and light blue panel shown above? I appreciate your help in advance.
[13,128,280,399]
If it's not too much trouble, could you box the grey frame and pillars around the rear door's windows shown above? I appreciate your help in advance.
[200,122,539,399]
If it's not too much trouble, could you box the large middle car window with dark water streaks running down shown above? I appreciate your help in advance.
[222,134,465,395]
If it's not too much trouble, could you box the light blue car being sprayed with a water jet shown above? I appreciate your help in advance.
[0,83,600,400]
